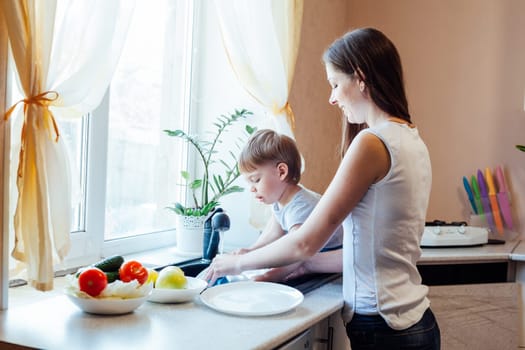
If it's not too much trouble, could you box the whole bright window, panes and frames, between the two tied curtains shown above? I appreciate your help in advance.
[8,0,259,269]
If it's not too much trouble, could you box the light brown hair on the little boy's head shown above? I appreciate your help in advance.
[239,129,301,184]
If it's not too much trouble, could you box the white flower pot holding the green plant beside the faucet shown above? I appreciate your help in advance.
[175,215,207,255]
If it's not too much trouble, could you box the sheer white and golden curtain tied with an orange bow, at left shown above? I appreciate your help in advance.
[0,0,135,290]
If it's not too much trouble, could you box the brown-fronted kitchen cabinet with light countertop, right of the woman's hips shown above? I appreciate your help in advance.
[418,242,522,350]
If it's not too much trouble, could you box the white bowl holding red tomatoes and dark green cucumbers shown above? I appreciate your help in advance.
[64,256,153,315]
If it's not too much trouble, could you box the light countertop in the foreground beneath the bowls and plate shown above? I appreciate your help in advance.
[0,280,343,350]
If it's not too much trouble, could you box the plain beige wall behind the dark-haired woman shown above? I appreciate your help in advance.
[291,0,525,238]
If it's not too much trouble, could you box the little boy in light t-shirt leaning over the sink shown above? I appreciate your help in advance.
[237,129,343,254]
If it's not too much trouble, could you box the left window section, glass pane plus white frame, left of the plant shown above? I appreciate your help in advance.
[9,0,193,268]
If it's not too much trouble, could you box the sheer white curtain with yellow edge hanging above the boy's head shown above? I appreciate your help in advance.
[215,0,303,137]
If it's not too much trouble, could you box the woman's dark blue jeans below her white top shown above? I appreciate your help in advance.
[346,309,441,350]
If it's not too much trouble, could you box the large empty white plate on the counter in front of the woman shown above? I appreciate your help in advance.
[200,281,304,316]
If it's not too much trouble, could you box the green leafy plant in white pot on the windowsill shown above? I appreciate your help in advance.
[164,109,255,254]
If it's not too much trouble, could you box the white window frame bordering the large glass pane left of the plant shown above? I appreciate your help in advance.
[56,1,200,270]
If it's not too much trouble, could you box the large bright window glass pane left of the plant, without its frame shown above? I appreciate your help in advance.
[104,0,191,240]
